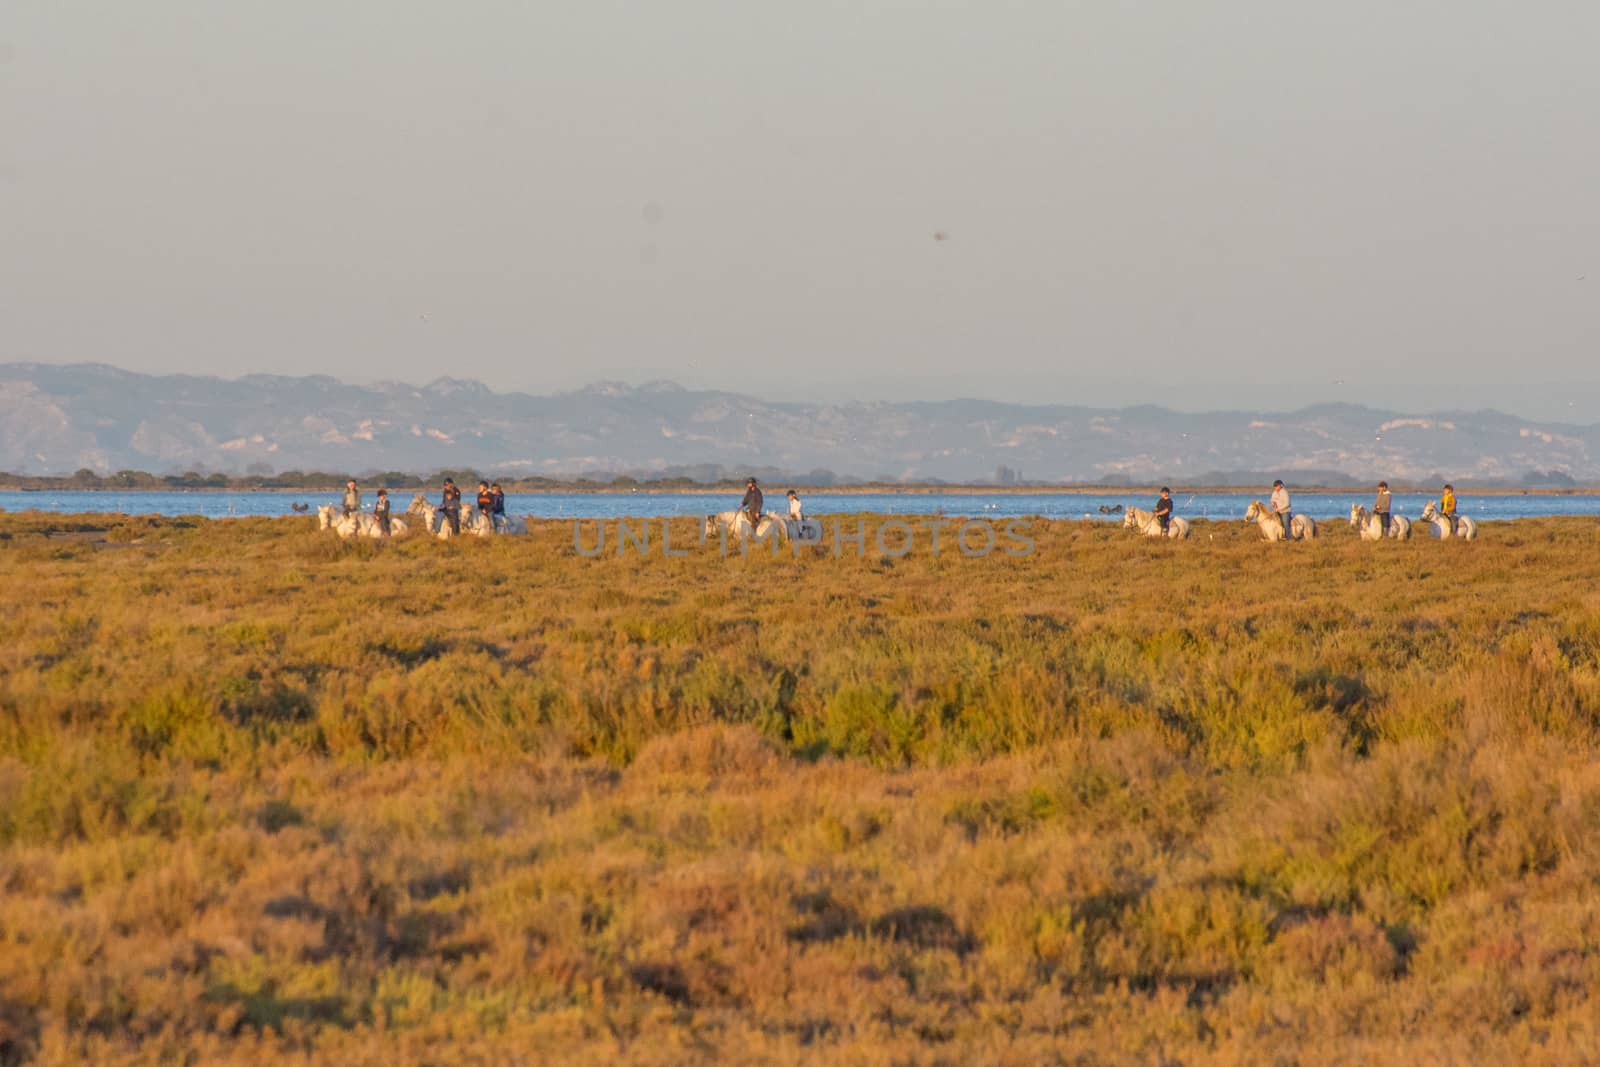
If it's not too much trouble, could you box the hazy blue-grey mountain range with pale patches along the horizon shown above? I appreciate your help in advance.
[0,363,1600,485]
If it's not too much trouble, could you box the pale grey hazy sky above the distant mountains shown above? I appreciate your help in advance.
[0,0,1600,422]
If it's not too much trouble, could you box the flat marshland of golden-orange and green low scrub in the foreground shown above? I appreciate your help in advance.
[0,514,1600,1065]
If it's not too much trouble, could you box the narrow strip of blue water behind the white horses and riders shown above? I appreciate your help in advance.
[0,490,1600,522]
